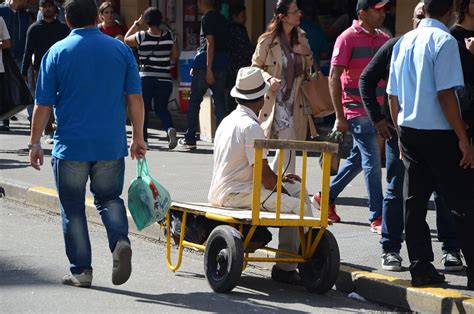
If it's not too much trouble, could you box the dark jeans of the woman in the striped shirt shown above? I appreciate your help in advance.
[142,77,173,141]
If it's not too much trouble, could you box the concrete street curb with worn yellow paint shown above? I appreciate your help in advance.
[0,179,474,314]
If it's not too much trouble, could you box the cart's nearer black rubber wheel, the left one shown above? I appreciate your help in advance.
[204,225,244,293]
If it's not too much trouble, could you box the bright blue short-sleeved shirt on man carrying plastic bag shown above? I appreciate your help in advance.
[36,27,141,161]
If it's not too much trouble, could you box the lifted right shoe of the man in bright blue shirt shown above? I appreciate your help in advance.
[112,240,132,285]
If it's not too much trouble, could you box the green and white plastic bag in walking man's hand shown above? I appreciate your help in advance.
[128,158,171,230]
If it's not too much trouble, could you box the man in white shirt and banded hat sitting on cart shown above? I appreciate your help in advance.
[208,67,313,284]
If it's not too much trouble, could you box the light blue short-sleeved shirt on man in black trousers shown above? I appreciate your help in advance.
[387,18,464,130]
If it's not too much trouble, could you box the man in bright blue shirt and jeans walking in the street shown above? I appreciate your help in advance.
[28,0,146,287]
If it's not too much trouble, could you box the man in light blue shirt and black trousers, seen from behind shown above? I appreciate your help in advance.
[387,0,474,289]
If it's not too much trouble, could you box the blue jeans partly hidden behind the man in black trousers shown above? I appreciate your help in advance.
[380,130,460,253]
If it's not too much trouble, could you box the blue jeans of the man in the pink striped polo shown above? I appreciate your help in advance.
[329,116,383,222]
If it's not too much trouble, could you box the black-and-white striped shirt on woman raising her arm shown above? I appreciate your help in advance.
[135,31,176,82]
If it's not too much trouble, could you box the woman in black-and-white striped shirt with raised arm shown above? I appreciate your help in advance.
[125,7,179,149]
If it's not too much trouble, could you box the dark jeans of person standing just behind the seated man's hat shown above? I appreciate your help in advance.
[184,69,227,143]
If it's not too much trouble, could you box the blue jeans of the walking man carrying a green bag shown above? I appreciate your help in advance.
[51,157,130,274]
